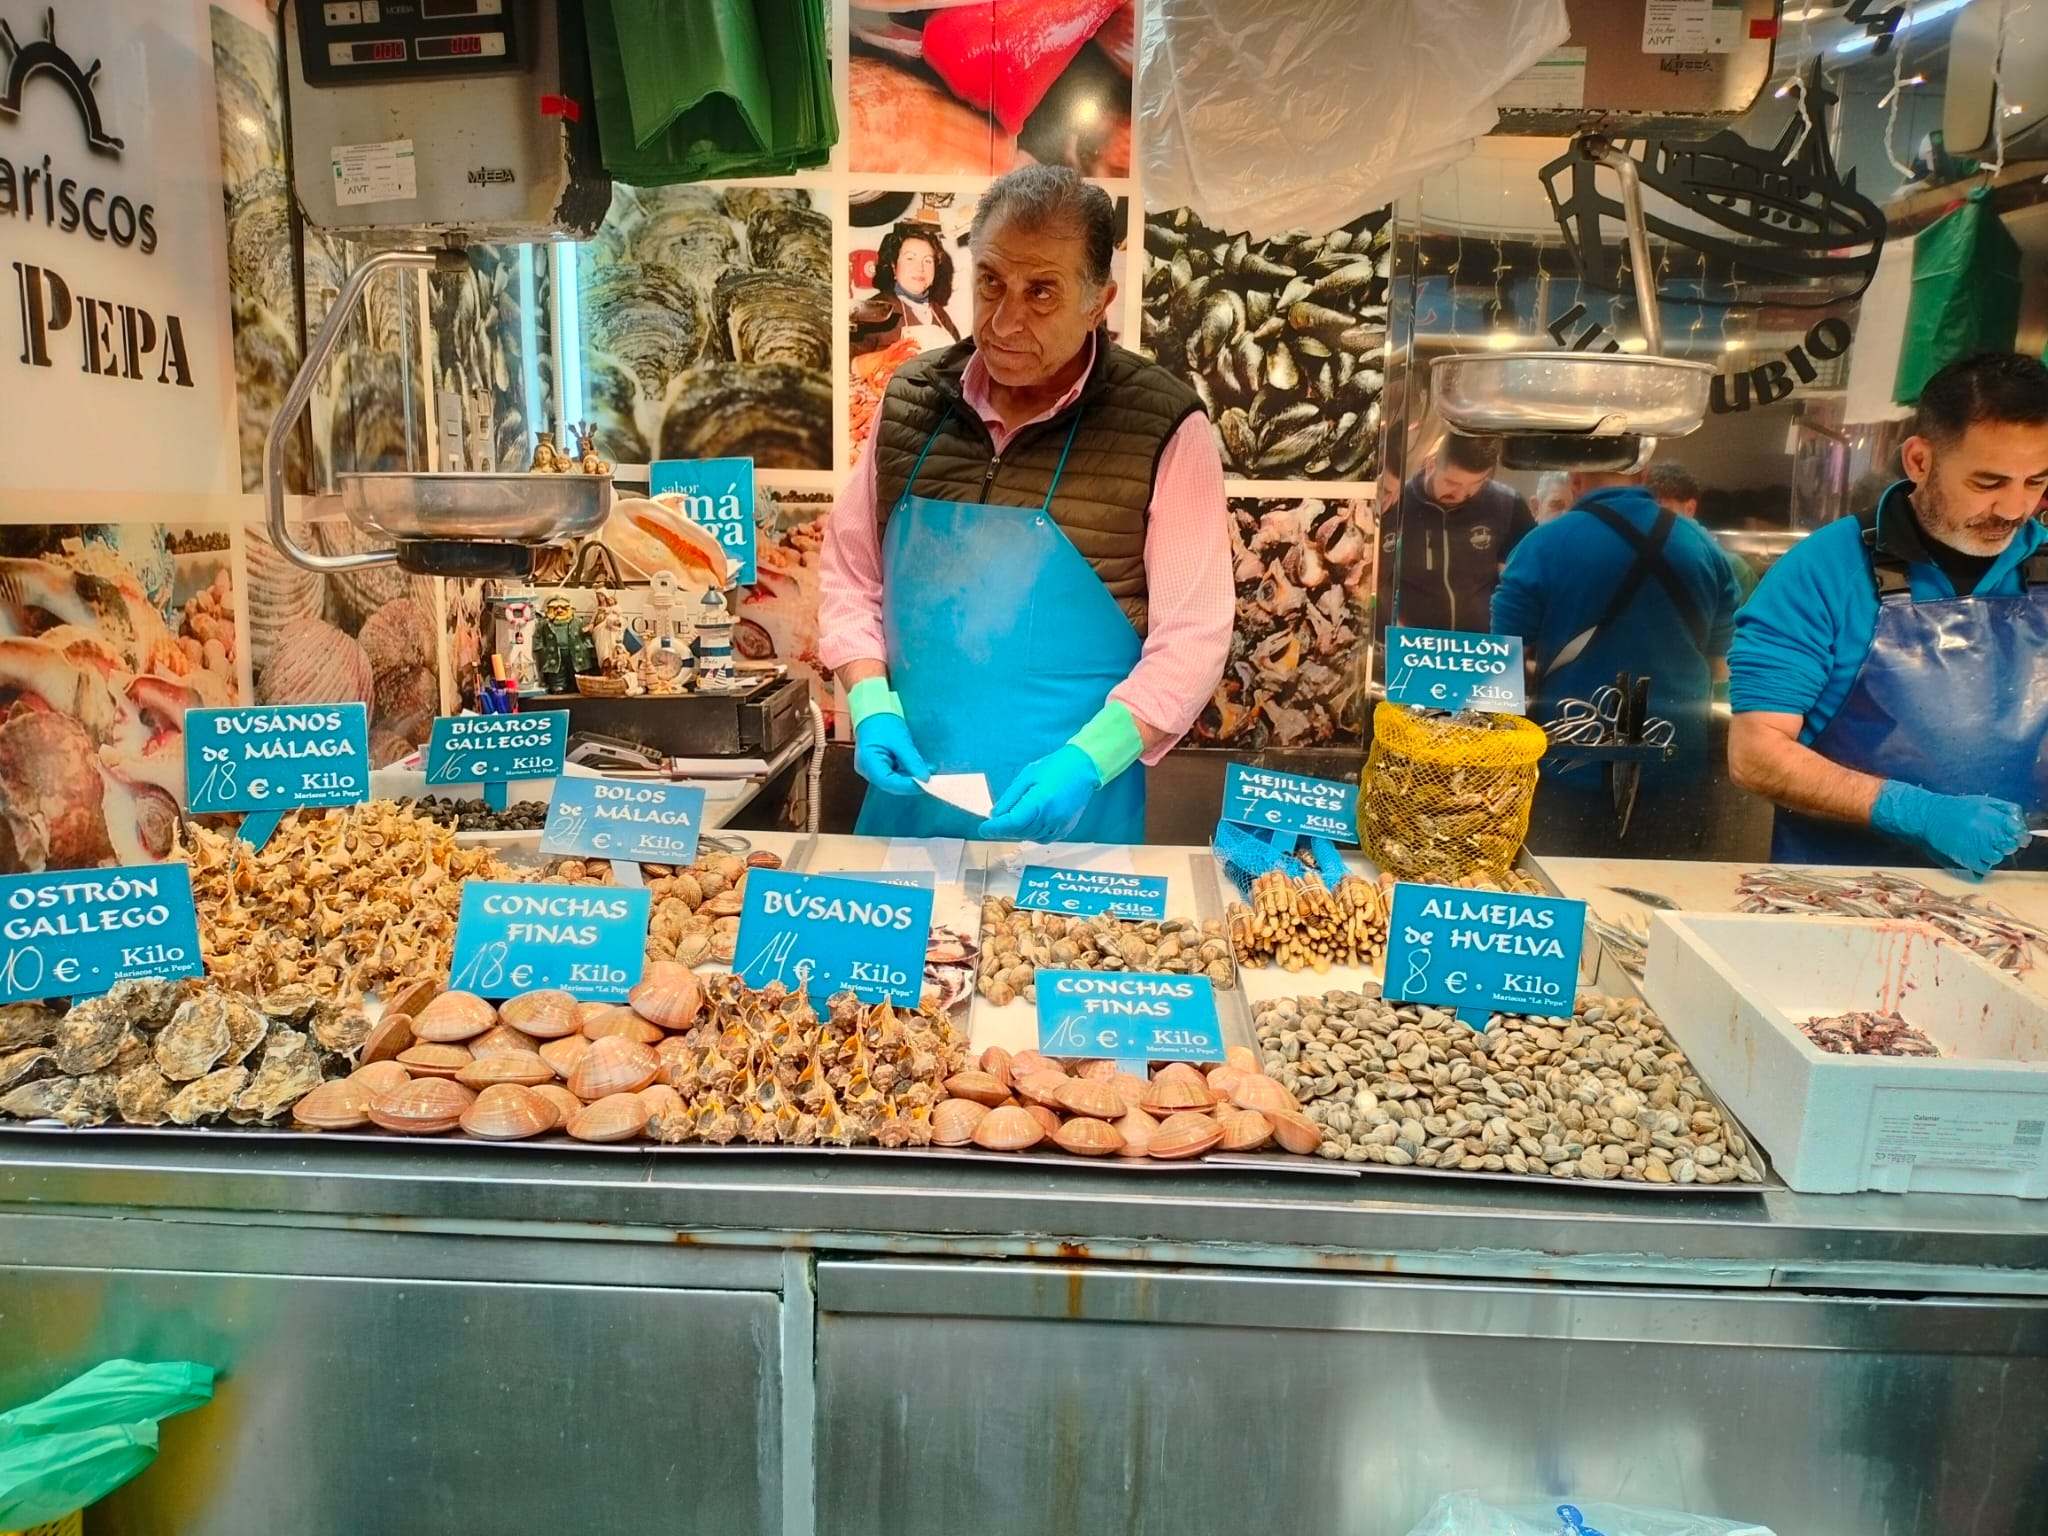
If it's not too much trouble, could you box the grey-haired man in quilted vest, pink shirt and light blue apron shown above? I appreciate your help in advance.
[817,166,1235,842]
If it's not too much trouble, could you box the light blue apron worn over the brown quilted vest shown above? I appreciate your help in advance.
[854,412,1145,844]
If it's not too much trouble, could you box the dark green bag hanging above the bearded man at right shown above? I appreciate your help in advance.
[1892,186,2019,406]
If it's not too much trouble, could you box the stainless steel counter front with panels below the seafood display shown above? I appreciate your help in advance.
[0,1130,2048,1536]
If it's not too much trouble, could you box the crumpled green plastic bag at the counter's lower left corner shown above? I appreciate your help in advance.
[0,1360,213,1530]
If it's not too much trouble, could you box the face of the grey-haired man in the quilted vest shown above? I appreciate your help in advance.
[975,219,1116,389]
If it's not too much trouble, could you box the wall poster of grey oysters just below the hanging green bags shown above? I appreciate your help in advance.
[575,186,831,469]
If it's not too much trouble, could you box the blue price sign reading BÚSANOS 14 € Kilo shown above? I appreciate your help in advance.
[733,868,932,1008]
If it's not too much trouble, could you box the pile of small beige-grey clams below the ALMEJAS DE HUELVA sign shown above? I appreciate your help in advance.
[1255,989,1763,1184]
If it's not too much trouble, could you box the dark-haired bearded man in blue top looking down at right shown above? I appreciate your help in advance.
[1729,352,2048,877]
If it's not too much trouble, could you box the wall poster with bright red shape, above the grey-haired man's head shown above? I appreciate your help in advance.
[846,0,1137,178]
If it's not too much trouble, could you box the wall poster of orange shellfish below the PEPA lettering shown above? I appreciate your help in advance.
[0,522,240,874]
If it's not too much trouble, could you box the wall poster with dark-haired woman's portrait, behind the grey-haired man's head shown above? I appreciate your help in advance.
[846,188,1130,465]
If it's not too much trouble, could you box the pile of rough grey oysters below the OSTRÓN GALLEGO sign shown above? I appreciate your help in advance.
[0,981,371,1126]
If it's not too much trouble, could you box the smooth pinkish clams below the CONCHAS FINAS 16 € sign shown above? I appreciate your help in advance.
[932,1047,1323,1161]
